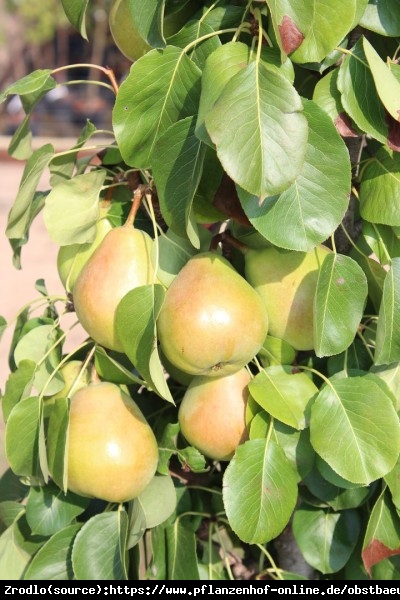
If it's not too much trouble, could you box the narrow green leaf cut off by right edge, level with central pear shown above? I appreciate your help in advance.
[375,257,400,365]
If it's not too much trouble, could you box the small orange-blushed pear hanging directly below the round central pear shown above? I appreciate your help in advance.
[178,368,250,460]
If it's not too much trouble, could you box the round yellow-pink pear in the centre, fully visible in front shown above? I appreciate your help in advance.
[157,251,268,376]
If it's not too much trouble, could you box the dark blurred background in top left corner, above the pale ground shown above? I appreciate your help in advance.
[0,0,131,136]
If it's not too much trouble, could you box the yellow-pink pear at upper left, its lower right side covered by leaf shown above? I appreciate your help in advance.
[73,224,155,352]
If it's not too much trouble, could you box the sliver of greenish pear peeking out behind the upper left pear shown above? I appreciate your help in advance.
[57,216,112,292]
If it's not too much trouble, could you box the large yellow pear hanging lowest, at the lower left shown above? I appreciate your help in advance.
[58,382,158,502]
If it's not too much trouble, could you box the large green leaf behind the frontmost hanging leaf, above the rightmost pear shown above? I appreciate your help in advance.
[238,100,351,251]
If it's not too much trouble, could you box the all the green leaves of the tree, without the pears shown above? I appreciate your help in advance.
[0,0,400,580]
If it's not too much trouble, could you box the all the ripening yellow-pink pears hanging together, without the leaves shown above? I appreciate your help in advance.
[48,195,329,502]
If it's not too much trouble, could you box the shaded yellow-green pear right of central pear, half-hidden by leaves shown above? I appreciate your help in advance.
[245,245,331,350]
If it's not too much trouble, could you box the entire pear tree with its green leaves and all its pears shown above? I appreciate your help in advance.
[0,0,400,583]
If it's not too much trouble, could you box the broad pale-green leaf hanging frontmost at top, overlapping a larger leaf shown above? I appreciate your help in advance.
[205,62,308,199]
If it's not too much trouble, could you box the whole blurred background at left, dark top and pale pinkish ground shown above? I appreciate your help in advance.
[0,0,131,474]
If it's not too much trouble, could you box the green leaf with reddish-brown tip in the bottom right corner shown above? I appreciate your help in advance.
[362,489,400,575]
